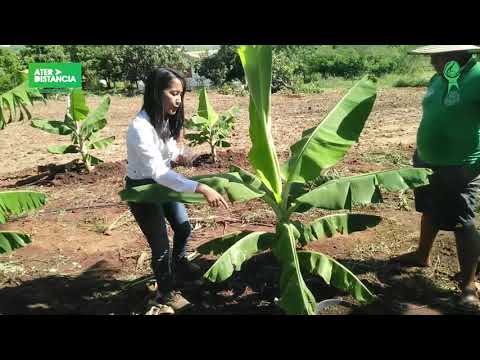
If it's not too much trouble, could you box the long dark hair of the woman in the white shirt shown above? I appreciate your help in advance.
[142,68,186,140]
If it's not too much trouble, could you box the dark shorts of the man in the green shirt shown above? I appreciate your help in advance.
[413,152,480,231]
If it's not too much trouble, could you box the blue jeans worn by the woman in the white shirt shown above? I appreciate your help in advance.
[126,177,192,290]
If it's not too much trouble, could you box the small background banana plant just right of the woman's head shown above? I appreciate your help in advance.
[185,88,239,163]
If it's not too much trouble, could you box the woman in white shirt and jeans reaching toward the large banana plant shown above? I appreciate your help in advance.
[126,68,228,312]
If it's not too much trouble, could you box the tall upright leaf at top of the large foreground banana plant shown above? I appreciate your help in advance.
[238,45,282,203]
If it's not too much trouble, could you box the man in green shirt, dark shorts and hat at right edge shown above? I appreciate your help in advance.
[397,45,480,309]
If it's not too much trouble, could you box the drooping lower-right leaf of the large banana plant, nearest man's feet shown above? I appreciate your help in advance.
[298,251,375,303]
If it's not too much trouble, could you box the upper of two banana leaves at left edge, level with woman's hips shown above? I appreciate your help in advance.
[0,191,47,224]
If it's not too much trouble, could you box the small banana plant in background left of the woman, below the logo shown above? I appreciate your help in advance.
[31,90,115,172]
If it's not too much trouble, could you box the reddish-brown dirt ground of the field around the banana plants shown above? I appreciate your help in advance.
[0,88,472,315]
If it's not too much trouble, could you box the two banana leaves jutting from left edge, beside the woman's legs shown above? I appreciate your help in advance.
[0,191,47,254]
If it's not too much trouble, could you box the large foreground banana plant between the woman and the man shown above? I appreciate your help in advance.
[120,46,430,315]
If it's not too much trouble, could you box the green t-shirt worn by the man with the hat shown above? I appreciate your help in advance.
[417,57,480,166]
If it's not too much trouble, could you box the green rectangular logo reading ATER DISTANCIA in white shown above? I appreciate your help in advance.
[28,63,82,92]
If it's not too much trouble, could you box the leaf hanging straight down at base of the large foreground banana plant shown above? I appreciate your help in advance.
[273,223,316,315]
